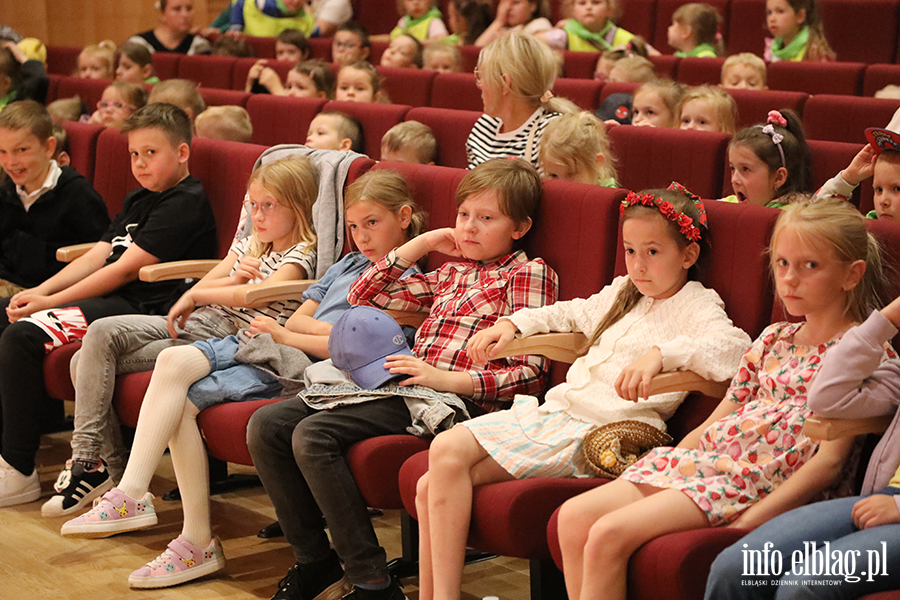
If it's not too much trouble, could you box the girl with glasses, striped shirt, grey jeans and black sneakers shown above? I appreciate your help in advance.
[42,159,317,520]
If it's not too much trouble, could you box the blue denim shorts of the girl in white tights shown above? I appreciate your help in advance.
[188,335,282,410]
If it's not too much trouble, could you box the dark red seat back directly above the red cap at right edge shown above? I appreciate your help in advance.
[803,94,900,143]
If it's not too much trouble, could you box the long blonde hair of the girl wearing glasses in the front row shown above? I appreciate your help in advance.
[247,156,319,258]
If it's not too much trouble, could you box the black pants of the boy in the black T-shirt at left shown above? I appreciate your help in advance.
[0,295,137,475]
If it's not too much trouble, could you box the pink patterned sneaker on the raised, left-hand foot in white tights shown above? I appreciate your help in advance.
[60,488,156,538]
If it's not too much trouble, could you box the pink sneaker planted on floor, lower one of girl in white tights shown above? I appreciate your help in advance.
[128,535,225,588]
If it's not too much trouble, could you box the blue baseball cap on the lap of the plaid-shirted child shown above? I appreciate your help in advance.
[328,306,415,390]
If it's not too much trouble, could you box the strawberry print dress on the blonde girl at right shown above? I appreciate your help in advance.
[620,323,872,526]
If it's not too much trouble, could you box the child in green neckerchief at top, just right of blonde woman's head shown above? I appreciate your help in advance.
[538,0,634,52]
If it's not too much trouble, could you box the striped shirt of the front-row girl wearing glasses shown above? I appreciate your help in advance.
[216,236,316,329]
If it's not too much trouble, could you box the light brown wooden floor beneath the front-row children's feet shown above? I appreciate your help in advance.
[0,433,529,600]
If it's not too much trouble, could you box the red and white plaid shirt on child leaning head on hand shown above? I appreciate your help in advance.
[348,250,559,411]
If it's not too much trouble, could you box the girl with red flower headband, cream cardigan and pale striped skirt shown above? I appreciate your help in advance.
[416,184,749,600]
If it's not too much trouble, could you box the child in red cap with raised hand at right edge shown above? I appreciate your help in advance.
[816,109,900,220]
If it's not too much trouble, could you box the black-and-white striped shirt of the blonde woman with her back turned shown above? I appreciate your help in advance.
[466,108,560,169]
